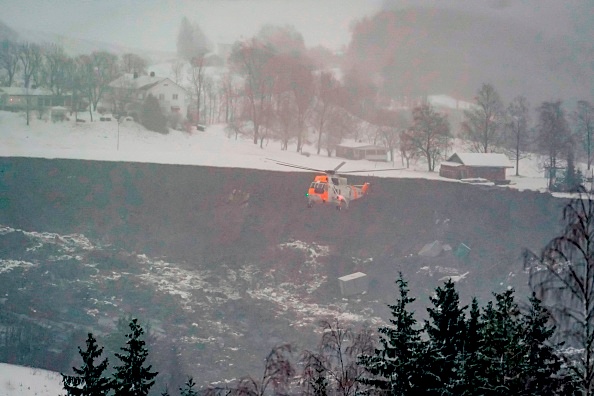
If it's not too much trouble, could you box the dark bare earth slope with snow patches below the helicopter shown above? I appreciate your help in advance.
[0,158,562,384]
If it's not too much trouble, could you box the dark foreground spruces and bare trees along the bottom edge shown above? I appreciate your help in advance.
[55,190,594,396]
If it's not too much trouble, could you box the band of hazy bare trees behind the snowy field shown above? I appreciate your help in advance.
[0,19,594,186]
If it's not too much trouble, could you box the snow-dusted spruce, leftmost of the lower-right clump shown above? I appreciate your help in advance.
[359,274,425,395]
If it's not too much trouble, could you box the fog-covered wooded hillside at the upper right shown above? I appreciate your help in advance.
[347,7,593,105]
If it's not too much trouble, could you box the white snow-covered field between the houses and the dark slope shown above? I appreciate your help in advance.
[0,111,547,191]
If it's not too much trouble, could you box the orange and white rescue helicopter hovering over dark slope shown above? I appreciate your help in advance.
[267,158,403,210]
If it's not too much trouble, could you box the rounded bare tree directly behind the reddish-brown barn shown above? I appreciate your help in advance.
[462,84,504,153]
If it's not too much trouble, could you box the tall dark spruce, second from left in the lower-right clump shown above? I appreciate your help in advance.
[424,280,467,395]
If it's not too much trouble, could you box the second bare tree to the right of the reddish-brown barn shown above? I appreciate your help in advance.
[536,101,571,189]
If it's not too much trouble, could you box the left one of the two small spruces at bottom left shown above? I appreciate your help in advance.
[62,333,111,396]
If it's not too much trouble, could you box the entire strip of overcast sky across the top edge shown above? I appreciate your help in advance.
[0,0,594,51]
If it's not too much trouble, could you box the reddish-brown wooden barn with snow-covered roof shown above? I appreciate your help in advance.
[439,153,513,184]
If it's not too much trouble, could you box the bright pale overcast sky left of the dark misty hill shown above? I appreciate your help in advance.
[0,0,383,51]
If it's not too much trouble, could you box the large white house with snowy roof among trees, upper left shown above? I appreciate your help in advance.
[108,72,190,117]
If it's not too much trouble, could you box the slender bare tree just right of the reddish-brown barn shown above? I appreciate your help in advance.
[505,96,530,176]
